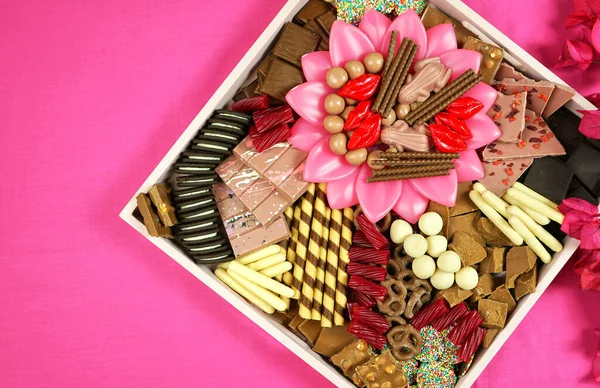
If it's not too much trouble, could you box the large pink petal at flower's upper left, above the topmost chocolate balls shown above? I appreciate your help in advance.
[329,20,375,67]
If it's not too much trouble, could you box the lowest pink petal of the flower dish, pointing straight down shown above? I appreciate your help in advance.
[356,163,402,222]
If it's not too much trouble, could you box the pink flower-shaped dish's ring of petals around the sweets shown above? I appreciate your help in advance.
[286,10,500,222]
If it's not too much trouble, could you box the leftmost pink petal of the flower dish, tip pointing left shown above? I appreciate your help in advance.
[285,81,334,125]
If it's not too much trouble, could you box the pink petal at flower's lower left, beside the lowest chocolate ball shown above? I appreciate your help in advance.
[304,138,358,182]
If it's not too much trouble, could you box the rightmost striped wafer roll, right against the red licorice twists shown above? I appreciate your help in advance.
[334,208,354,326]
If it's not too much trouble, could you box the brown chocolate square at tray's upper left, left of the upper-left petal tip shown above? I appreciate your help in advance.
[269,22,321,67]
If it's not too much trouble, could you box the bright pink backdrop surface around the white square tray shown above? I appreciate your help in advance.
[0,0,600,388]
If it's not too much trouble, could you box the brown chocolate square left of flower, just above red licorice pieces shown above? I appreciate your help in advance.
[260,57,304,102]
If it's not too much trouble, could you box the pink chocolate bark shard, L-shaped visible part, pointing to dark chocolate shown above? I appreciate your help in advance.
[483,110,566,161]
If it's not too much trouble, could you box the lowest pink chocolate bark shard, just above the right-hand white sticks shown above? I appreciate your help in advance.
[479,158,533,197]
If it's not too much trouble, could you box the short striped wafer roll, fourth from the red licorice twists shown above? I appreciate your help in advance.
[292,183,316,299]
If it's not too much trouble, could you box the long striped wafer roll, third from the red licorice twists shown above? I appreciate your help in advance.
[296,183,326,319]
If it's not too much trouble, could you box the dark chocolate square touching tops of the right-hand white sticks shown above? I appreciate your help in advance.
[524,153,576,203]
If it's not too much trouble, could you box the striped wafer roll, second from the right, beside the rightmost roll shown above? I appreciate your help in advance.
[321,209,344,327]
